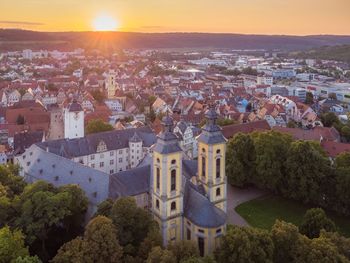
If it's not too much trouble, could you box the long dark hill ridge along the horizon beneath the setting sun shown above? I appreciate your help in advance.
[0,29,350,51]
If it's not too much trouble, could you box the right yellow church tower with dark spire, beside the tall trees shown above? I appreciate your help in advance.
[197,106,227,212]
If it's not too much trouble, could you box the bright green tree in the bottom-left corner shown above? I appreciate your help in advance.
[0,226,29,263]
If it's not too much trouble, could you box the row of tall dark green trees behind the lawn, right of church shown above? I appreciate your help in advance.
[226,131,350,215]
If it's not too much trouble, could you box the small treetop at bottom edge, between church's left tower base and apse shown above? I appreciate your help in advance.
[168,240,199,262]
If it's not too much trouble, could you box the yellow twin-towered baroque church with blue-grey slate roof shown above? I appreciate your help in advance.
[150,108,227,255]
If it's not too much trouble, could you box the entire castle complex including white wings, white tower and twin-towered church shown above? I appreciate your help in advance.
[15,104,227,255]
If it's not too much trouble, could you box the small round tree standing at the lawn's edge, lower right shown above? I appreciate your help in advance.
[299,208,336,238]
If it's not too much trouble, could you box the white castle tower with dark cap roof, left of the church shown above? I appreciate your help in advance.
[64,99,84,139]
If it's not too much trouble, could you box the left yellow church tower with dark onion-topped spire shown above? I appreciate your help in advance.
[151,116,184,246]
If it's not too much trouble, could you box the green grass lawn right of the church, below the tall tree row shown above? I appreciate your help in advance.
[236,196,350,237]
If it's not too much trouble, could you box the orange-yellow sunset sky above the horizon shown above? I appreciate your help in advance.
[0,0,350,35]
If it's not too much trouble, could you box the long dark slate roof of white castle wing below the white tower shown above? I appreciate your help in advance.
[37,126,156,158]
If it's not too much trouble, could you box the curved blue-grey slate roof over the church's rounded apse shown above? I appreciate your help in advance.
[184,182,226,228]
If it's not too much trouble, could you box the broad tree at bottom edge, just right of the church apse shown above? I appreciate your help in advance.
[215,226,274,263]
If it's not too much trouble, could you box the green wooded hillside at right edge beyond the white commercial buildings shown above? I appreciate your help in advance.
[291,45,350,64]
